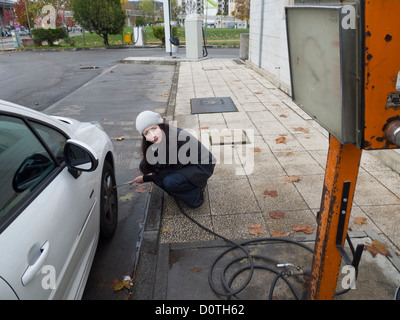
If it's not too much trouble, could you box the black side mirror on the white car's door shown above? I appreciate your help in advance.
[64,139,99,173]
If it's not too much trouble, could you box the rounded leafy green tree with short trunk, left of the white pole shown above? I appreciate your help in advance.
[72,0,126,46]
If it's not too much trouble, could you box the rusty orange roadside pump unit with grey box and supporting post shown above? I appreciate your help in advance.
[286,0,400,299]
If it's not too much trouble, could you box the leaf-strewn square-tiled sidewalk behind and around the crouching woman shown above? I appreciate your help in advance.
[133,59,400,300]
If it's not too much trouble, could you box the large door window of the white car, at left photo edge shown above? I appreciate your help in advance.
[0,115,56,224]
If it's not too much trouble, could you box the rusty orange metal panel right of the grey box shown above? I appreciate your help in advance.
[362,0,400,149]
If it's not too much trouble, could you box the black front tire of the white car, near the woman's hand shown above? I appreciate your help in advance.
[100,161,118,238]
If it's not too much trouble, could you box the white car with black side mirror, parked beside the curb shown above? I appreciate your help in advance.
[0,100,118,299]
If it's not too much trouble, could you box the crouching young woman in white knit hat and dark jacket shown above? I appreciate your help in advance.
[131,111,216,208]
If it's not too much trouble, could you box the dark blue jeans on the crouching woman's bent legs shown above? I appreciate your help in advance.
[163,172,203,208]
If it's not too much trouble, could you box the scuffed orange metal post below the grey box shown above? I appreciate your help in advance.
[310,135,362,300]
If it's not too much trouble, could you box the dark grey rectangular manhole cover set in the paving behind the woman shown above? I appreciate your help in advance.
[190,97,238,114]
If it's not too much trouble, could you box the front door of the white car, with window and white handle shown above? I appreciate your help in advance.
[0,114,98,299]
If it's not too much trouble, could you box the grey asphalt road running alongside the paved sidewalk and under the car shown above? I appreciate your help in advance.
[0,49,239,300]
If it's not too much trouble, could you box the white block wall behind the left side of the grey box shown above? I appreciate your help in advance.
[248,0,293,93]
